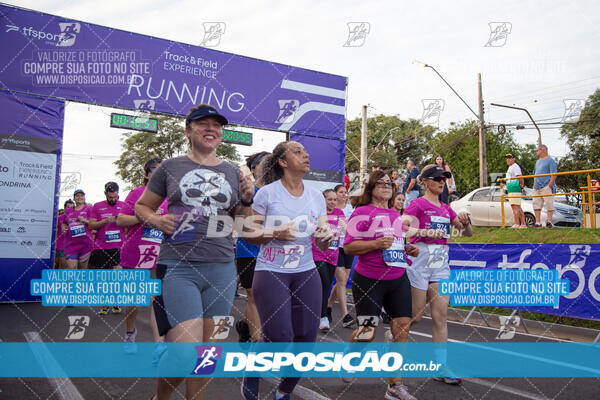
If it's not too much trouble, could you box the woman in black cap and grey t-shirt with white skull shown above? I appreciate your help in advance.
[135,104,254,398]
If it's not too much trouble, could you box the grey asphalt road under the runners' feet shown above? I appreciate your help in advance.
[0,296,600,400]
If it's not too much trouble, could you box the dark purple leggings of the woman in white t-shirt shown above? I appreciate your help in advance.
[252,268,321,393]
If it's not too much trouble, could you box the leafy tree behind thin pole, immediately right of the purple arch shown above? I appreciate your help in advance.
[346,114,435,173]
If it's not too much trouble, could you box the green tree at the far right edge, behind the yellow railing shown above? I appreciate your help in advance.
[556,89,600,202]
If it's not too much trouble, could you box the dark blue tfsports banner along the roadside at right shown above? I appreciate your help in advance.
[450,243,600,320]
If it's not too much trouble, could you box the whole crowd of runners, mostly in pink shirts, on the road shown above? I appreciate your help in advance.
[57,104,472,400]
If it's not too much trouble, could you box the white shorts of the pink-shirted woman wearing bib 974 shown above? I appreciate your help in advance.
[406,242,450,290]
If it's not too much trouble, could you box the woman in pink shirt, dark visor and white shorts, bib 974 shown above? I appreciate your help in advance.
[403,164,473,385]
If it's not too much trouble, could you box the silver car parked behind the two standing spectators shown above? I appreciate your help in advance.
[450,186,583,227]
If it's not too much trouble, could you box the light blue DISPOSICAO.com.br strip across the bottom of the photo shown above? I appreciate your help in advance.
[0,342,600,378]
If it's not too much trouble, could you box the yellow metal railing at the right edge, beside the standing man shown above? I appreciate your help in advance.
[498,168,600,229]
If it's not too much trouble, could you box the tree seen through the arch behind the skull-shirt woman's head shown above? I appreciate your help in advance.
[115,115,241,189]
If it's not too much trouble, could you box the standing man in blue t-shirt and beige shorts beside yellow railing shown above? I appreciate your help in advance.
[533,144,556,228]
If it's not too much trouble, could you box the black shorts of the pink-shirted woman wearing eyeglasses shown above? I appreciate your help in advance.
[352,271,412,318]
